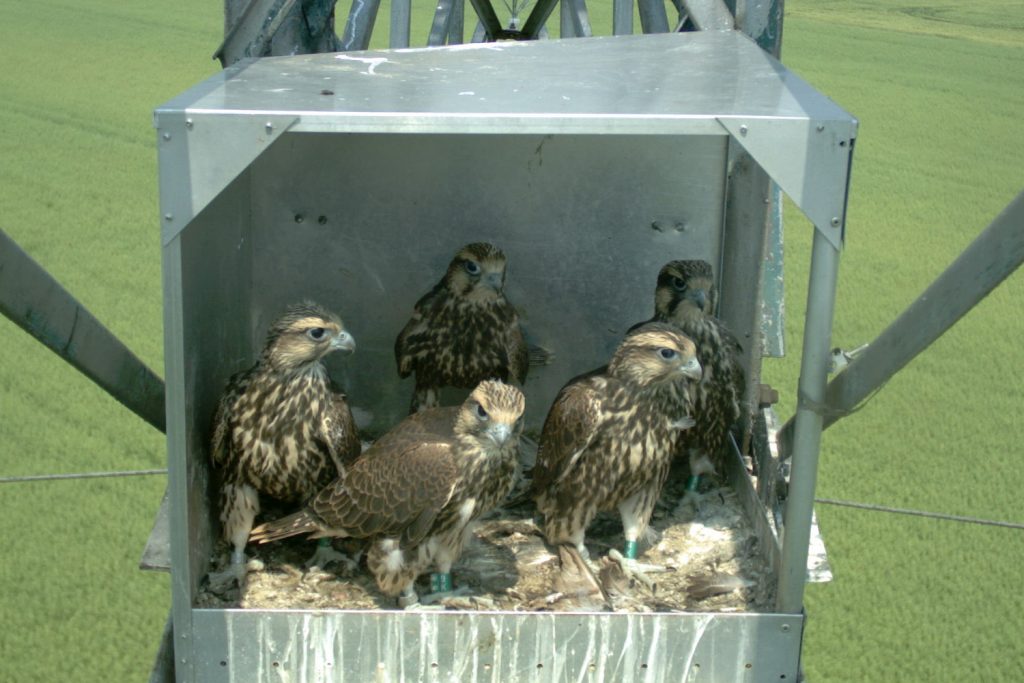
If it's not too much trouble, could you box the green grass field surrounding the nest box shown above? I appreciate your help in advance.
[0,0,1024,682]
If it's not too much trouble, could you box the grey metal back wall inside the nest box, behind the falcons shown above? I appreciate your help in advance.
[243,134,726,432]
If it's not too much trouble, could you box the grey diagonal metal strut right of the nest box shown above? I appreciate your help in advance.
[782,193,1024,450]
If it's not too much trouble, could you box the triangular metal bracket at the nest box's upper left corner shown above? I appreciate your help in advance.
[156,111,299,246]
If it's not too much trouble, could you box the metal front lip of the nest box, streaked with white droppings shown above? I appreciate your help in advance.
[194,609,803,683]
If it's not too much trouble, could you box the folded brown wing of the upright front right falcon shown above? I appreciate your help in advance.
[534,377,601,494]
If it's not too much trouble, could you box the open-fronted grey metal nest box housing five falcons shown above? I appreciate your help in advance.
[155,32,857,681]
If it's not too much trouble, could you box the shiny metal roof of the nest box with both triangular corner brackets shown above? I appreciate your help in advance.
[156,32,856,244]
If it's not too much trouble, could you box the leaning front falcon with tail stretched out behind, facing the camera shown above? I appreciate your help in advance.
[245,381,525,606]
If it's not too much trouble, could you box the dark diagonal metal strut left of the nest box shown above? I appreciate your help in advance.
[0,230,165,431]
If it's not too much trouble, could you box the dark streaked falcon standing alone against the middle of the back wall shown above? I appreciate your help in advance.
[394,243,529,412]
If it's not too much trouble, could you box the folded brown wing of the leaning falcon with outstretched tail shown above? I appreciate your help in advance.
[310,435,458,543]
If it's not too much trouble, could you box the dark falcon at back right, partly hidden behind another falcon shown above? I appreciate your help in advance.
[630,260,744,489]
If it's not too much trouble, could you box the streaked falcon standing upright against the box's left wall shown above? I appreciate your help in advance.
[203,302,360,589]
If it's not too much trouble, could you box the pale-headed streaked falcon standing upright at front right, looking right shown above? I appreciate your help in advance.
[534,323,700,577]
